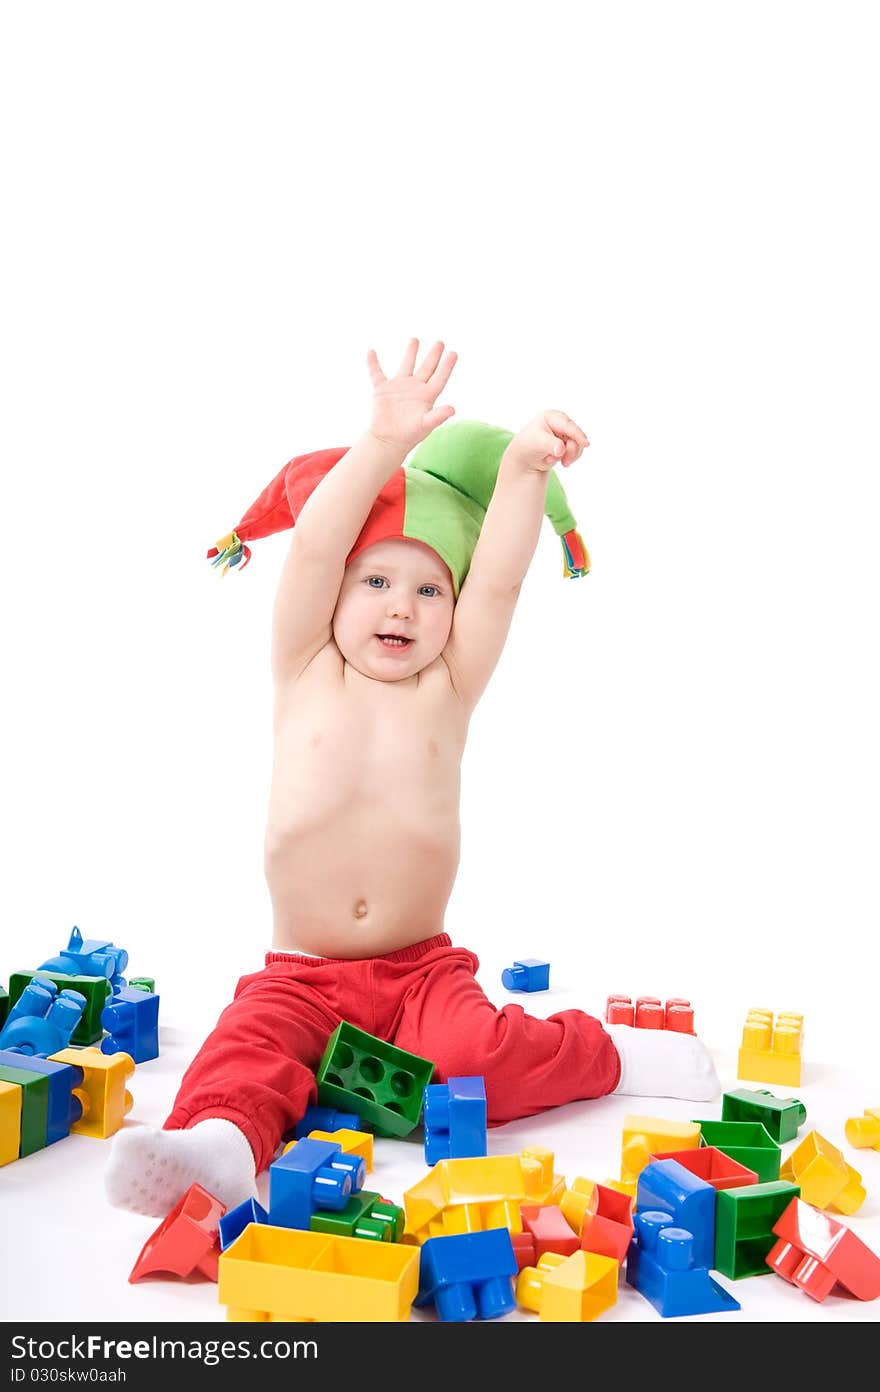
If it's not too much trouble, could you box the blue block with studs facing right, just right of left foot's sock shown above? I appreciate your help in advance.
[269,1136,366,1228]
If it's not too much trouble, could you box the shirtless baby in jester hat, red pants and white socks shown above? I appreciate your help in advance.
[106,338,720,1217]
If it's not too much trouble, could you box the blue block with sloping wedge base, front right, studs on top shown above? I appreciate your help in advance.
[627,1208,739,1320]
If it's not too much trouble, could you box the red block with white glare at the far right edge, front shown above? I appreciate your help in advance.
[767,1199,880,1302]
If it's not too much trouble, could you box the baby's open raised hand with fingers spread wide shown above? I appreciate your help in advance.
[366,338,458,452]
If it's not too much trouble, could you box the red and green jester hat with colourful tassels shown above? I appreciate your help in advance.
[207,420,590,599]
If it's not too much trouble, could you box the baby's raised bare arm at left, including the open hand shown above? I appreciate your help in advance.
[272,338,455,682]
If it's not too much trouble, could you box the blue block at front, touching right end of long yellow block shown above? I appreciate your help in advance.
[412,1228,517,1320]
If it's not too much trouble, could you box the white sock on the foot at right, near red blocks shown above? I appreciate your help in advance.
[604,1025,721,1102]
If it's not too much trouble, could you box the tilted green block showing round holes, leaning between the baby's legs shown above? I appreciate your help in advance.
[315,1020,434,1136]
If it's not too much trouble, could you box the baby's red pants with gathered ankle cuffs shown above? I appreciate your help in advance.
[164,933,620,1173]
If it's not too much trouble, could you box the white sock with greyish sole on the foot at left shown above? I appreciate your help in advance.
[104,1116,258,1218]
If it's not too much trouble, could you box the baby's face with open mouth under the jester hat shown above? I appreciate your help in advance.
[333,537,455,682]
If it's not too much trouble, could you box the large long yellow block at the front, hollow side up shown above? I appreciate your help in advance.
[217,1222,421,1322]
